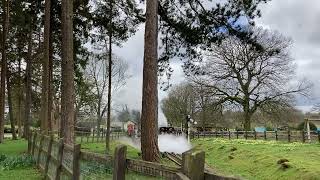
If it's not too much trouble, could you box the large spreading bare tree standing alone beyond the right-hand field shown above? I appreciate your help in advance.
[191,29,309,130]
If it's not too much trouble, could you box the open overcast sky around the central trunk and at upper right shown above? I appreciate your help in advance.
[113,0,320,124]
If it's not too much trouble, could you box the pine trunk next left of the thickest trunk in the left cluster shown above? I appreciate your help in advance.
[40,0,51,134]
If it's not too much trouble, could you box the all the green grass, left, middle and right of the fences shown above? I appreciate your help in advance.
[0,138,320,180]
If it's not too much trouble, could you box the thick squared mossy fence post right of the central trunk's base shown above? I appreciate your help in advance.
[181,150,205,180]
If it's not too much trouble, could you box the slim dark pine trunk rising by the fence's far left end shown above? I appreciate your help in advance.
[23,24,32,139]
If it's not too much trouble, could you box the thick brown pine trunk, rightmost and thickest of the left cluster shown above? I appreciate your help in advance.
[61,0,75,144]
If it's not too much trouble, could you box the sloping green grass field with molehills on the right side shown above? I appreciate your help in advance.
[193,138,320,180]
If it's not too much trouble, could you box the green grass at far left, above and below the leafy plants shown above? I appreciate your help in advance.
[0,139,42,180]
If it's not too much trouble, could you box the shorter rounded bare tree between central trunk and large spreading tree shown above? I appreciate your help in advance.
[161,83,222,127]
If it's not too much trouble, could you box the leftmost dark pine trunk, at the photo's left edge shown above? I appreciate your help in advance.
[0,0,10,143]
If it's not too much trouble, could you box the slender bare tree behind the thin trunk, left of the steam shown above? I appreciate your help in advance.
[86,53,128,136]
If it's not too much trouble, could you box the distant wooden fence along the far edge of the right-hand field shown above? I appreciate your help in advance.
[191,130,320,143]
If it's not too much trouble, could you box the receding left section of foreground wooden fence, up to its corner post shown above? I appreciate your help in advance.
[29,133,81,180]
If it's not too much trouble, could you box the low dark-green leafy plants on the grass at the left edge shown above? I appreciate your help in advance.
[0,155,34,170]
